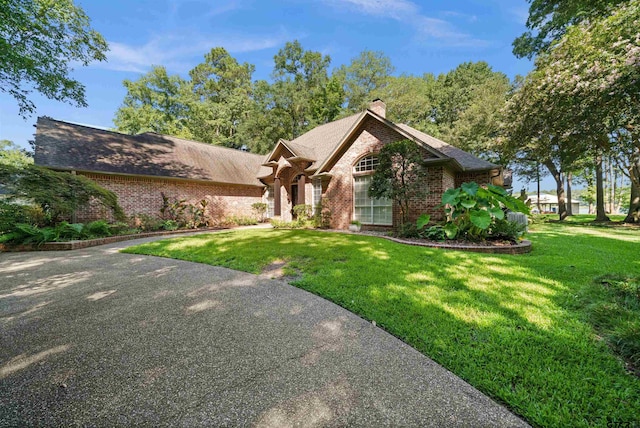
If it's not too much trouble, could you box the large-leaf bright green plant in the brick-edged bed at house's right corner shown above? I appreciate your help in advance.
[442,182,529,241]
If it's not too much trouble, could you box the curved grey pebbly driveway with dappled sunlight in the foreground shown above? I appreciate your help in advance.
[0,239,527,427]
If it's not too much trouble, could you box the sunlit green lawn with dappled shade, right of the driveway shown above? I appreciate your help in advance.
[126,217,640,427]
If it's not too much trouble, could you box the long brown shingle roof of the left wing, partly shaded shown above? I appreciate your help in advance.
[35,118,270,186]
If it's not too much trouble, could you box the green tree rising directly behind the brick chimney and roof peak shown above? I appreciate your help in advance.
[335,50,394,113]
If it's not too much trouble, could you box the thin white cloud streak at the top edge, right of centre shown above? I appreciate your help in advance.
[321,0,488,47]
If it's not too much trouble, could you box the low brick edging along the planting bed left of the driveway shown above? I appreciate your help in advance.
[0,227,225,252]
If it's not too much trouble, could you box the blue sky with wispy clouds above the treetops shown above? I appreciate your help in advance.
[0,0,544,189]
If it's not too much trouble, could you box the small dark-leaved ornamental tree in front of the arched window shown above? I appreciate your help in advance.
[369,140,427,224]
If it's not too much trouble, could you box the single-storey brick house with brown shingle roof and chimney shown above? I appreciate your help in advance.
[35,100,502,229]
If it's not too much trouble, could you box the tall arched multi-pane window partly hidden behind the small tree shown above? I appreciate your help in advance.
[353,155,393,226]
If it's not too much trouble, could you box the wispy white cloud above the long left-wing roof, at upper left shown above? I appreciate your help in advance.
[102,33,288,73]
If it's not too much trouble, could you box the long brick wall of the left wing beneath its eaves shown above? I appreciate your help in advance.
[76,173,264,222]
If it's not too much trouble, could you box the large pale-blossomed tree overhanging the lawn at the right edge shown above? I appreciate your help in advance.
[502,0,640,219]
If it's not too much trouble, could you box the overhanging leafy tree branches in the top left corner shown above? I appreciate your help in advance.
[0,0,108,118]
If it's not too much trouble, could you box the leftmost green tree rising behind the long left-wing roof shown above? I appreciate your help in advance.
[113,66,192,138]
